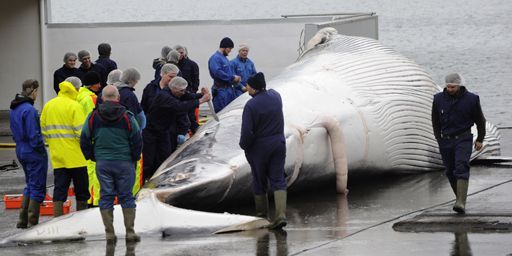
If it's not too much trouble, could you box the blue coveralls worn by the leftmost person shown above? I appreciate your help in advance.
[9,95,48,203]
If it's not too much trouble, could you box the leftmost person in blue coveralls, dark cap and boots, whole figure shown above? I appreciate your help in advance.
[9,79,48,228]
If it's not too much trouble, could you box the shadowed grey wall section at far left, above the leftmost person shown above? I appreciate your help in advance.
[0,0,42,110]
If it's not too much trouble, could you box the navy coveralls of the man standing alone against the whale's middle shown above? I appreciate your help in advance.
[239,89,286,195]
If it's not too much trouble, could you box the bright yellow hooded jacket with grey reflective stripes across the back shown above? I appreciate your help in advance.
[41,81,86,169]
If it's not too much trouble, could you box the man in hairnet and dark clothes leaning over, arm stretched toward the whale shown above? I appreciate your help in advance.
[143,77,210,180]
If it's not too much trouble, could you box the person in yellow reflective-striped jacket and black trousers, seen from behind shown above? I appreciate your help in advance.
[41,81,90,216]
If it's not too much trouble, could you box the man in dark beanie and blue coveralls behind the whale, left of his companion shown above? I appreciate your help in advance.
[208,37,240,113]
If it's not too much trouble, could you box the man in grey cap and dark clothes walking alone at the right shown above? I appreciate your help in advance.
[432,73,485,213]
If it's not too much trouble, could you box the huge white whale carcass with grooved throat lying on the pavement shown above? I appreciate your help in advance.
[145,28,500,208]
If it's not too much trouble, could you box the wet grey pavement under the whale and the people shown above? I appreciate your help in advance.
[0,130,512,256]
